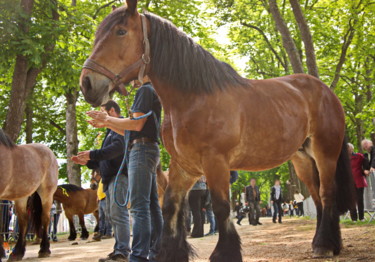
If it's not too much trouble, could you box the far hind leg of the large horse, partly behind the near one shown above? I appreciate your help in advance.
[292,150,323,252]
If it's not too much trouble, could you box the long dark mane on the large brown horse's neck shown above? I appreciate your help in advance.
[145,13,248,94]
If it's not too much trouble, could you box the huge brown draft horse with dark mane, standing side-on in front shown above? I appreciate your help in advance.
[80,0,354,262]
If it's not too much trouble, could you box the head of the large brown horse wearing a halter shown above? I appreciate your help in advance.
[80,0,150,106]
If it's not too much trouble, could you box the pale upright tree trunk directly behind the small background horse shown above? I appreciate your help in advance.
[65,90,81,186]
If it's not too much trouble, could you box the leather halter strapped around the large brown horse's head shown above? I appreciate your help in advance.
[83,14,151,95]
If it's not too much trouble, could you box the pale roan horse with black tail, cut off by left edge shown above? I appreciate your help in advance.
[0,129,58,261]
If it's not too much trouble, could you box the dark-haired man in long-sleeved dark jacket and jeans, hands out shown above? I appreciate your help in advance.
[72,100,130,262]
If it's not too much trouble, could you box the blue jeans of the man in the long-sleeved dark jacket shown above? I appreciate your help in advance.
[105,175,130,257]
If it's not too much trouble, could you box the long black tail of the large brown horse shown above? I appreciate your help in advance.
[336,137,357,213]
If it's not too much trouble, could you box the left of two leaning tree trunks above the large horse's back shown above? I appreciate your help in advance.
[269,0,304,73]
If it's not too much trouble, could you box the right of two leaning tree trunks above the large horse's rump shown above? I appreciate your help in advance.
[290,0,319,78]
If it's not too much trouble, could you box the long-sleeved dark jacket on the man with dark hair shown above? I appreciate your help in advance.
[87,129,127,187]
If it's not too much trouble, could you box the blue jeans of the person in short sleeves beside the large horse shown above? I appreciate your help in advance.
[128,143,163,262]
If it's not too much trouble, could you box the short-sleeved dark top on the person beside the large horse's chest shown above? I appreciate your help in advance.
[130,82,161,142]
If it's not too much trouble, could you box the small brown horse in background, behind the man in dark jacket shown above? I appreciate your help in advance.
[53,184,99,241]
